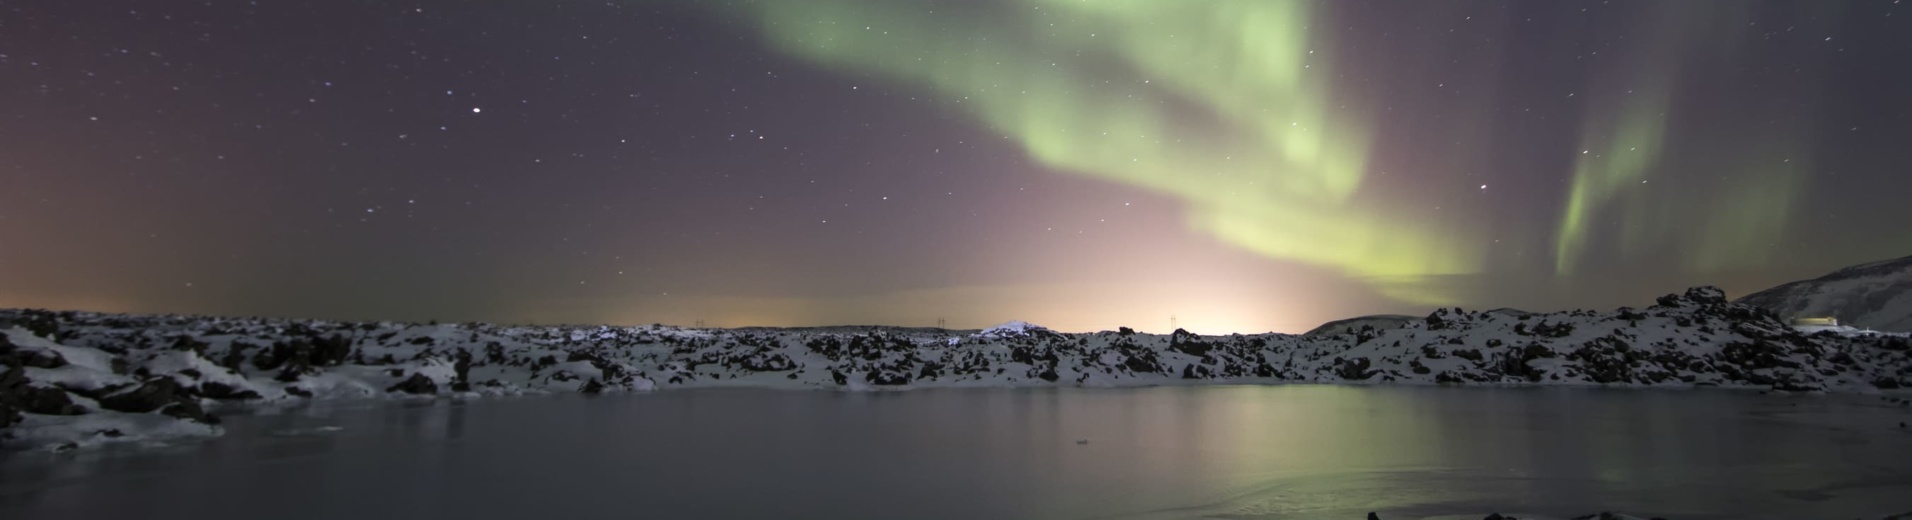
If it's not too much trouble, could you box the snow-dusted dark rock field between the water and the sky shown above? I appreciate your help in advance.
[0,287,1912,449]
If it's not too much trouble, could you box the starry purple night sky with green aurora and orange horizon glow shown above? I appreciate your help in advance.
[0,0,1912,333]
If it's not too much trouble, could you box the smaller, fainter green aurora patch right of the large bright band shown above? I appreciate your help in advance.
[1554,2,1812,275]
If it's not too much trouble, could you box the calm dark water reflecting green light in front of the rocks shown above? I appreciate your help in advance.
[0,386,1912,518]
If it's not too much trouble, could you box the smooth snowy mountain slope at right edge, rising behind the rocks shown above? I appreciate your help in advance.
[1738,256,1912,333]
